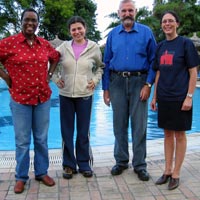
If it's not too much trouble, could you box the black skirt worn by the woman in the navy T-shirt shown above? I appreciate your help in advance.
[158,101,192,131]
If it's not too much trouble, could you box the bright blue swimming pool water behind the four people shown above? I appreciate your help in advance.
[0,80,200,150]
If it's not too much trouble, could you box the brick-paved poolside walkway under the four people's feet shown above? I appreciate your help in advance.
[0,133,200,200]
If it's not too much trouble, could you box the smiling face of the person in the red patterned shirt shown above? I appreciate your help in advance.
[22,11,38,38]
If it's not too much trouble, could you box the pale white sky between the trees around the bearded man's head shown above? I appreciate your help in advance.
[93,0,154,44]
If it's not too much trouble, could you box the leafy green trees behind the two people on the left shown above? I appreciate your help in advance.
[0,0,101,41]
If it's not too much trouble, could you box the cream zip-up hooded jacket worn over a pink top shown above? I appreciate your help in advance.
[52,40,104,98]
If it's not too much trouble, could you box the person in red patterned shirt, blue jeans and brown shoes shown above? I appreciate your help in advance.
[0,8,60,193]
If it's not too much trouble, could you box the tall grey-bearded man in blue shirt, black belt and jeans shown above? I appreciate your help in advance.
[102,0,156,181]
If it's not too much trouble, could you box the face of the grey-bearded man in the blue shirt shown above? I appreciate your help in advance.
[118,2,137,28]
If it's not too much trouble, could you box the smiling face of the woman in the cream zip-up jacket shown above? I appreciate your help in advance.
[70,22,86,44]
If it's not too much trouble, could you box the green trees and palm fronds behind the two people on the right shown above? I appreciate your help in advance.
[104,0,200,42]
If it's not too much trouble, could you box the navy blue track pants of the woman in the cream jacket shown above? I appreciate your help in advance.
[59,95,92,171]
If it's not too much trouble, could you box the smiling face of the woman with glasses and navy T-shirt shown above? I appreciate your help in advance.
[161,13,179,39]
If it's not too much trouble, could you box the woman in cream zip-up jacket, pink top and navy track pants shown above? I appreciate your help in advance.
[53,16,104,179]
